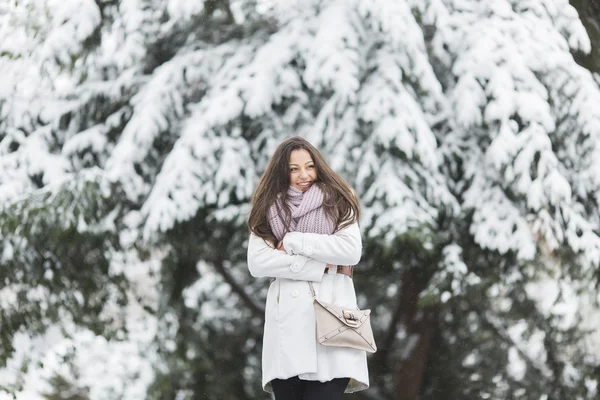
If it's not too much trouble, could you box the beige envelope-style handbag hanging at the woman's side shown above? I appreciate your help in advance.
[308,281,377,353]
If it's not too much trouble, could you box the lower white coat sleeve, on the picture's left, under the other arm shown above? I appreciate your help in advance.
[248,234,327,282]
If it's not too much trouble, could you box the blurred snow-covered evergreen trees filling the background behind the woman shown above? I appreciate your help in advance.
[0,0,600,400]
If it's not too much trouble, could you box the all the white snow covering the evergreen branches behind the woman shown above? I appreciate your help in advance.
[0,0,600,400]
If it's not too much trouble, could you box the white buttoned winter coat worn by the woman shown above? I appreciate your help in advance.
[248,223,369,393]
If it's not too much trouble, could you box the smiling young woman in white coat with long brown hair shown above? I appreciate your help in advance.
[248,137,369,400]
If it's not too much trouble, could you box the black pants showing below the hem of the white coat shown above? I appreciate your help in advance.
[271,376,350,400]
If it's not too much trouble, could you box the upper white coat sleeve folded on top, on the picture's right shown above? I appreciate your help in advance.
[283,222,362,265]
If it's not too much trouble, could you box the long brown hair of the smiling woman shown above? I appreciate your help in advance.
[248,136,360,247]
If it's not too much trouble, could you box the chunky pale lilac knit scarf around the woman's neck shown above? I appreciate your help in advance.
[269,184,335,240]
